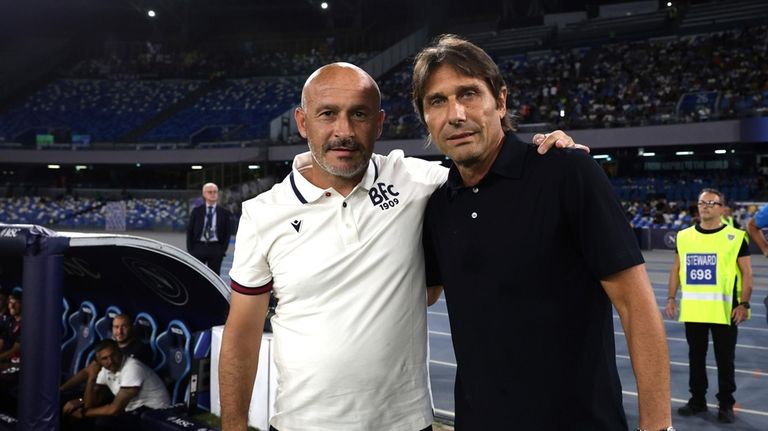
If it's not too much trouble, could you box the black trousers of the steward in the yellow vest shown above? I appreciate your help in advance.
[685,322,738,408]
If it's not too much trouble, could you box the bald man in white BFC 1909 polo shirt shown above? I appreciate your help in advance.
[219,63,573,431]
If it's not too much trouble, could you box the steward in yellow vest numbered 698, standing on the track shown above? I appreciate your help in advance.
[665,189,752,423]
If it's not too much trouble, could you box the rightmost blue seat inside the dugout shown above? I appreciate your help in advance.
[155,320,192,403]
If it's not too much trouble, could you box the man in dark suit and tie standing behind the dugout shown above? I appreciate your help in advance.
[187,183,232,274]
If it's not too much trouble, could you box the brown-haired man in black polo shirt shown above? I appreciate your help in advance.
[413,36,671,431]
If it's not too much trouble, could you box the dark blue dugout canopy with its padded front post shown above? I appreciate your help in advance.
[0,224,229,430]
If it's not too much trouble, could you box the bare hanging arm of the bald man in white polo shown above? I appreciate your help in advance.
[219,291,269,431]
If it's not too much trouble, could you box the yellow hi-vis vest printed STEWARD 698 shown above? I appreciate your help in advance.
[677,225,744,325]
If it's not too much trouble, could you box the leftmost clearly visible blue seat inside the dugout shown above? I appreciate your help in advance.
[61,301,96,378]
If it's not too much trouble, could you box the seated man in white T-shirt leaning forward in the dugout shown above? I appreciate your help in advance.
[62,339,170,431]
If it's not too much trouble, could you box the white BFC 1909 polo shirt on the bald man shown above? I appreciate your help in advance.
[230,150,448,431]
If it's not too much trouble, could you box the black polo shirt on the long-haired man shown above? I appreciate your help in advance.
[424,134,643,431]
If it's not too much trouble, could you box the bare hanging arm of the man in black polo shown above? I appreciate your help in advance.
[601,264,672,430]
